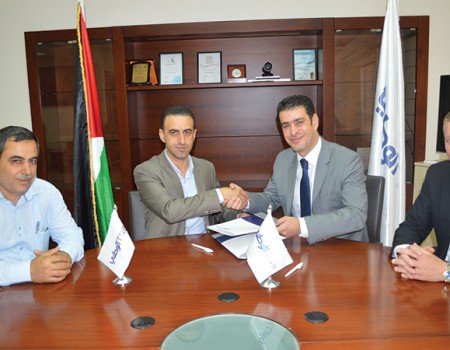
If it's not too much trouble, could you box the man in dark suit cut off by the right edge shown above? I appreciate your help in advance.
[392,112,450,283]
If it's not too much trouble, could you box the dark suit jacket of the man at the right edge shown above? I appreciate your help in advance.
[392,160,450,259]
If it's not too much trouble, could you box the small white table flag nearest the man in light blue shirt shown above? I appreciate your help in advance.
[98,207,135,278]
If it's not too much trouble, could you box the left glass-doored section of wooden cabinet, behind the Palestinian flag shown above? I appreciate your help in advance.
[25,28,122,217]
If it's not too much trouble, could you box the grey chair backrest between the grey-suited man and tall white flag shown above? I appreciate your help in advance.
[366,175,385,243]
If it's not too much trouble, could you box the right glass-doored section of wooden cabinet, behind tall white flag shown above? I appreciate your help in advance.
[334,17,428,186]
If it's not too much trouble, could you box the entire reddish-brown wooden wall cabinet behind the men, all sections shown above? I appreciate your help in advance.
[25,17,428,232]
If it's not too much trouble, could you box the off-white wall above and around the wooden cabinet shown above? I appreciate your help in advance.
[0,0,450,160]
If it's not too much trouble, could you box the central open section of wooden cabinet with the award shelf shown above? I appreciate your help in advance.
[119,19,323,194]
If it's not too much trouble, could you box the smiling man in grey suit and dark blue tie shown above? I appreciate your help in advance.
[230,95,368,244]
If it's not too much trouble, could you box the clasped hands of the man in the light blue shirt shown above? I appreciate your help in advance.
[30,247,72,283]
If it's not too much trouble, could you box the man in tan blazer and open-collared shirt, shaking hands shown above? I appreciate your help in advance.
[133,106,248,238]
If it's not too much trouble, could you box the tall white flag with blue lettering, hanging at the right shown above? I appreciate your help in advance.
[368,0,405,246]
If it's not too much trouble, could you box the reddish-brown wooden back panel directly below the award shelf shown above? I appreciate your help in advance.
[128,85,317,139]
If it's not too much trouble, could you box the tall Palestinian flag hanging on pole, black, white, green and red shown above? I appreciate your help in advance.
[73,0,114,249]
